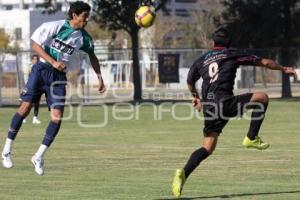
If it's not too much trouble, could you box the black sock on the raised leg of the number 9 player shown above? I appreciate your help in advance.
[247,103,268,140]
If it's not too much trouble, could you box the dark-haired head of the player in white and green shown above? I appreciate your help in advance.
[68,1,91,29]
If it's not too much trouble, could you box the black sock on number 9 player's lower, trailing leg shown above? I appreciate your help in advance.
[184,147,209,178]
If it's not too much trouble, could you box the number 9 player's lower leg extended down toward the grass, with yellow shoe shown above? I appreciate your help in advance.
[172,132,219,197]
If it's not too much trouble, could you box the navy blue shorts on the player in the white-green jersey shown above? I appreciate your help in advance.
[21,62,67,111]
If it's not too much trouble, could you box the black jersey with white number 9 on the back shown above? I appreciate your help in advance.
[187,48,260,100]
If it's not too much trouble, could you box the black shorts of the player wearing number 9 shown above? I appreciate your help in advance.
[203,93,253,136]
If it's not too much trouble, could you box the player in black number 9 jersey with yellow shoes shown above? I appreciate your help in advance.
[172,28,295,197]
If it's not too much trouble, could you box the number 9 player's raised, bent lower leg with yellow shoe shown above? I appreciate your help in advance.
[243,92,270,150]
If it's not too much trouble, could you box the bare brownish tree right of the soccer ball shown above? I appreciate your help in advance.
[152,0,223,48]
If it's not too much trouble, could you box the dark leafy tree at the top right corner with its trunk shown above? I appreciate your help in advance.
[222,0,300,97]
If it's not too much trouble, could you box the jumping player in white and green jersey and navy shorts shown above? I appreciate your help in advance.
[2,1,105,175]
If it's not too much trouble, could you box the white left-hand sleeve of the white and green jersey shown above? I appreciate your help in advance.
[31,22,59,46]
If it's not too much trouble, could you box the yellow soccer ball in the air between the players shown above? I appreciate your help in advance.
[134,6,155,28]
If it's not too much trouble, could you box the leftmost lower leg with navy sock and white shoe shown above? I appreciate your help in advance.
[2,101,31,168]
